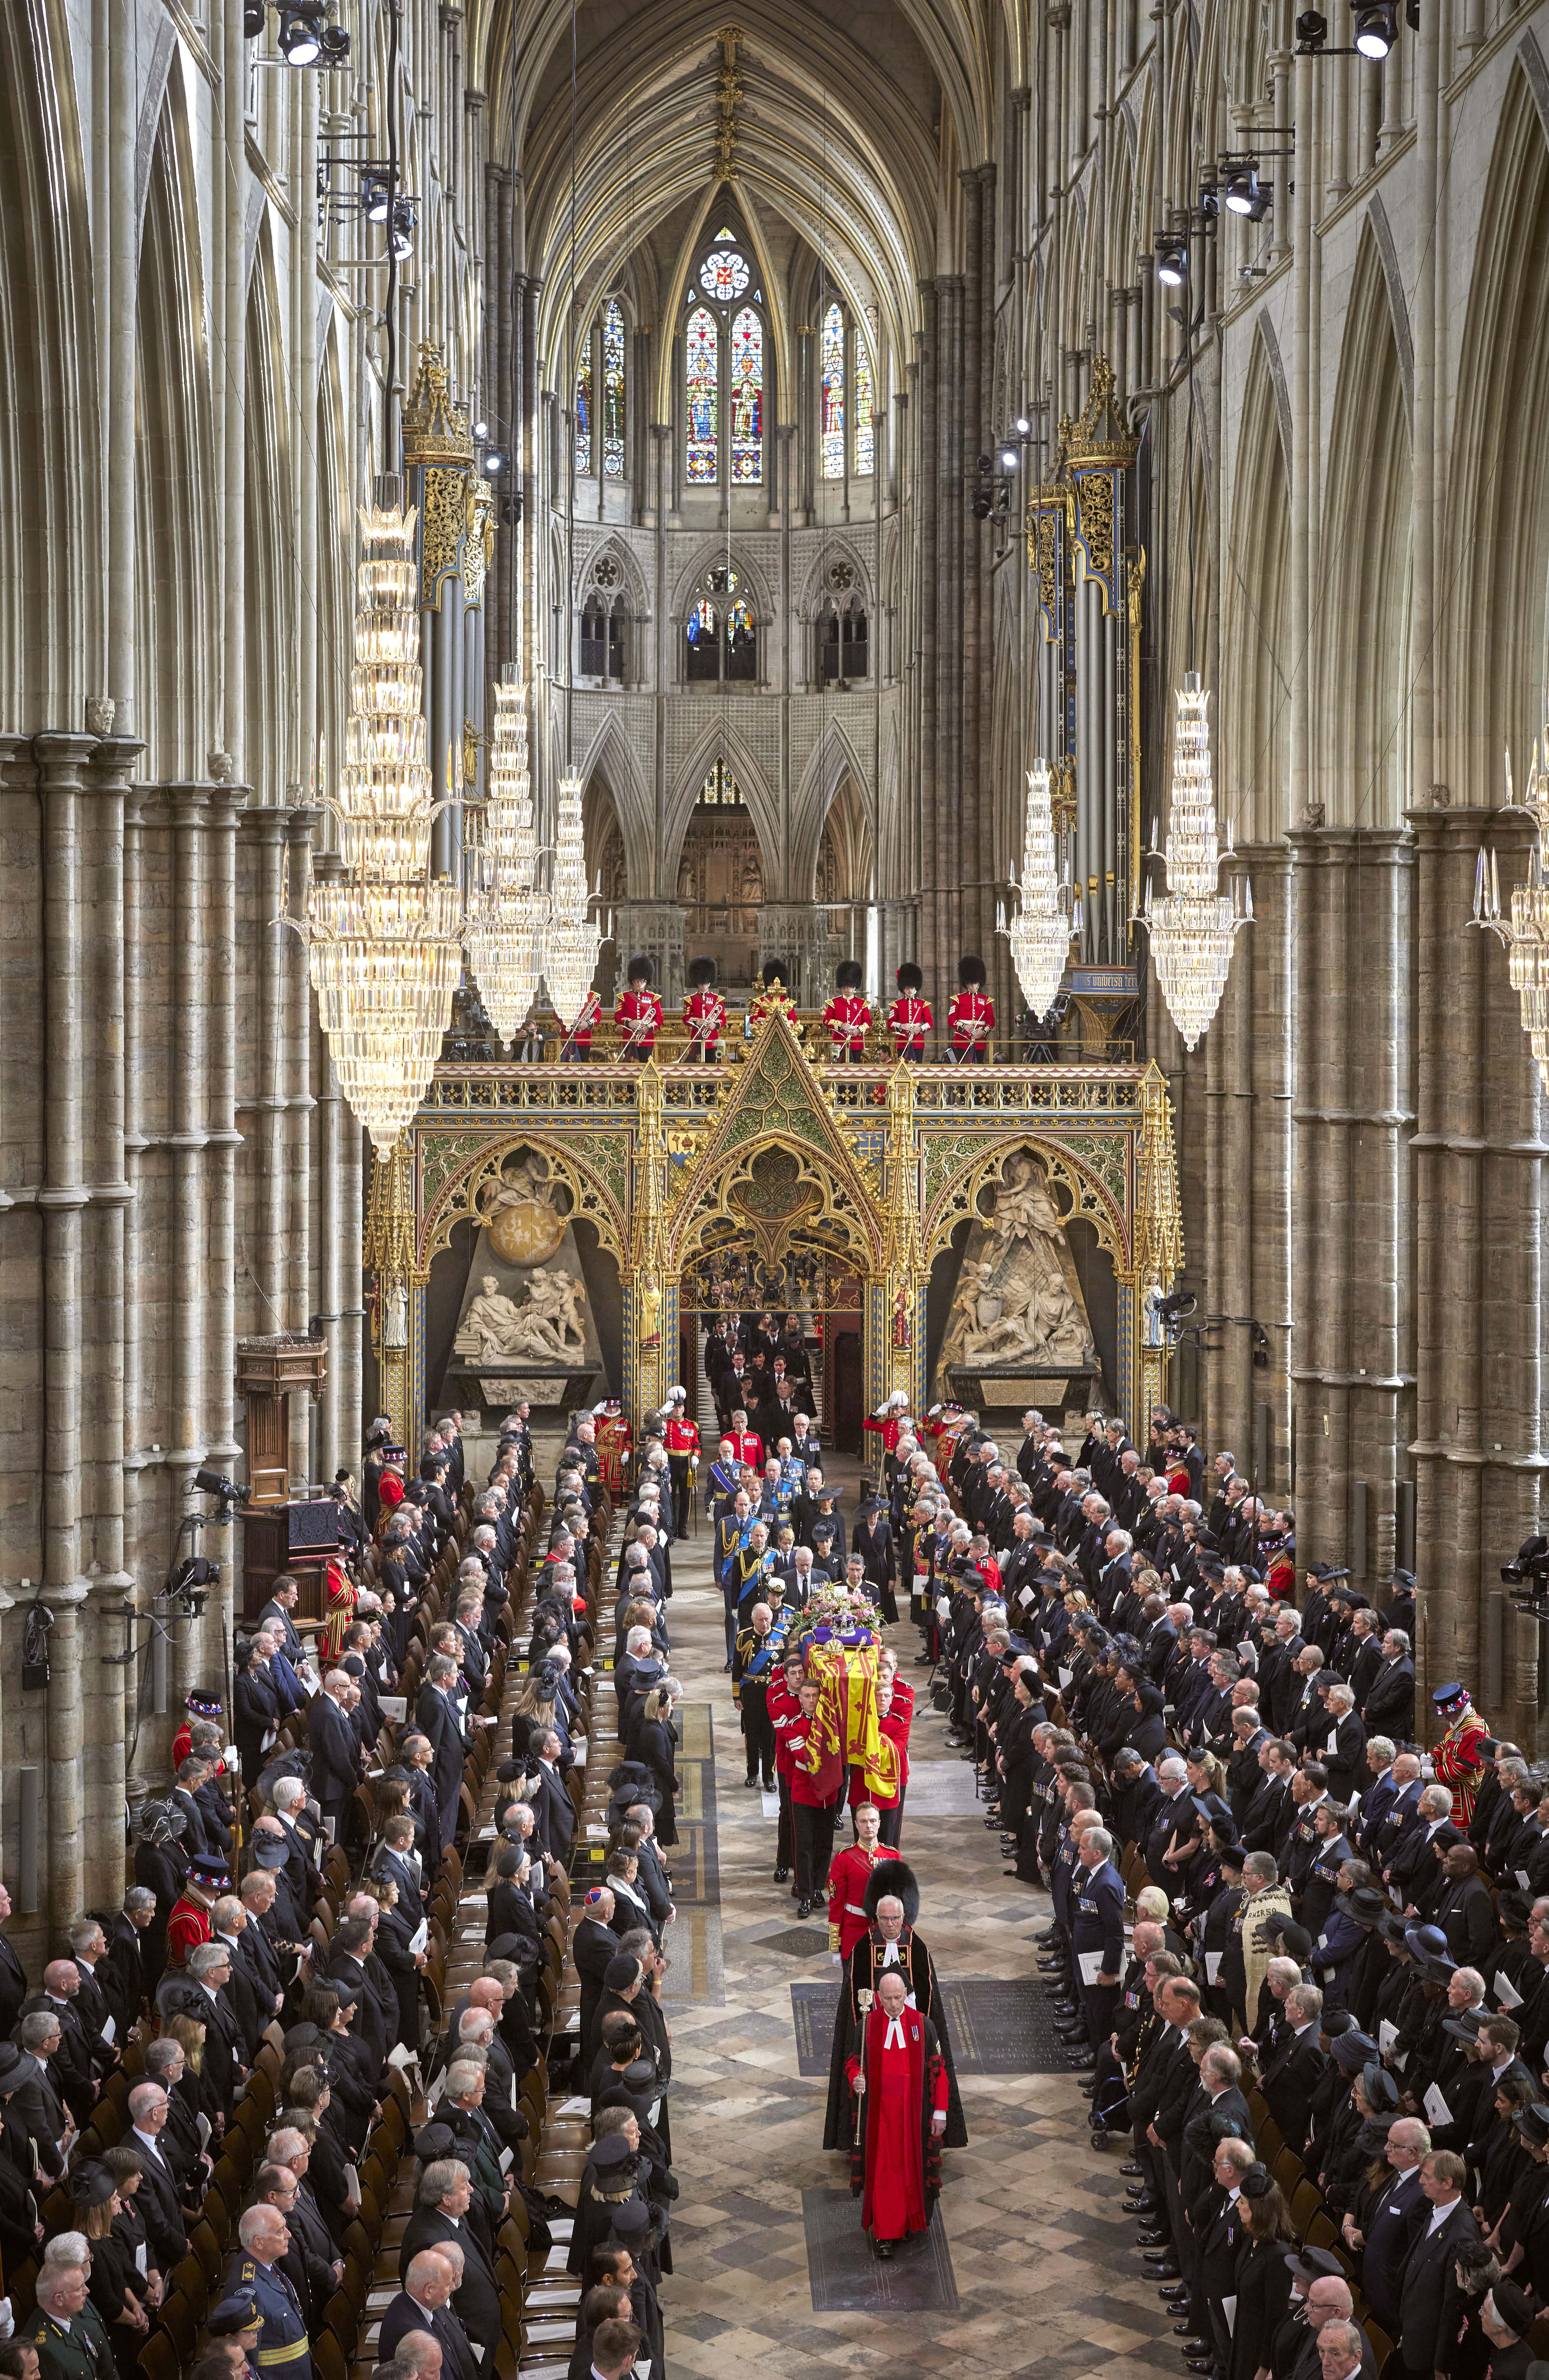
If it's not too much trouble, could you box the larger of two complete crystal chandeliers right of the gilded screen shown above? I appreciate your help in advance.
[1140,669,1254,1050]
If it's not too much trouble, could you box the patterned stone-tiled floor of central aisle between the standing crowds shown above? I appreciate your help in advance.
[664,1466,1180,2380]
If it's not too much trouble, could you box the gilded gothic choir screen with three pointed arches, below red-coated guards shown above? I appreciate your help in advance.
[366,1014,1183,1430]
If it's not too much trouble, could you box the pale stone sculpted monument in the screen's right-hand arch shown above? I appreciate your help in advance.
[938,1150,1099,1397]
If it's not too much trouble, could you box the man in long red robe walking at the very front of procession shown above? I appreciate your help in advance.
[847,1968,947,2256]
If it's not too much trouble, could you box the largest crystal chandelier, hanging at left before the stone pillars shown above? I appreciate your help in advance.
[304,505,462,1154]
